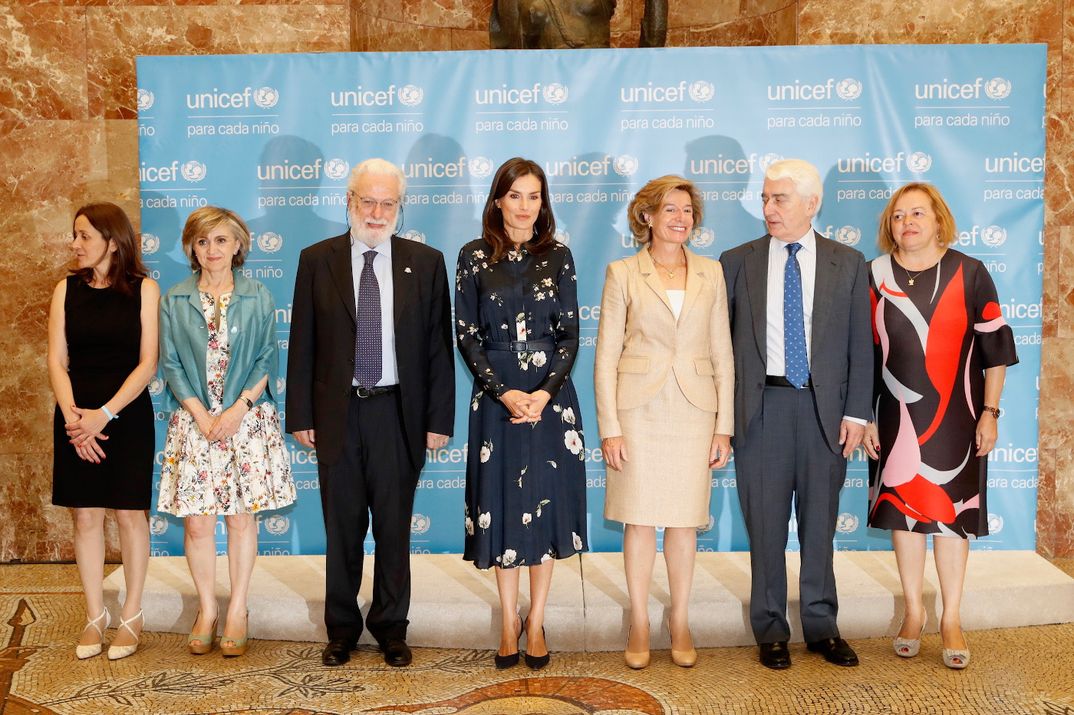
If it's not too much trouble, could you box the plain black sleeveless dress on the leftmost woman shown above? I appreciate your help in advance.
[53,276,155,509]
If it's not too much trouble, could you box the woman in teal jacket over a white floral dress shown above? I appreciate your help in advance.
[157,206,294,656]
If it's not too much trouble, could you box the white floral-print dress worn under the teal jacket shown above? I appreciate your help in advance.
[157,292,295,516]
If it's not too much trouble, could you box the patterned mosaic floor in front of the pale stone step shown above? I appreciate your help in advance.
[0,559,1074,715]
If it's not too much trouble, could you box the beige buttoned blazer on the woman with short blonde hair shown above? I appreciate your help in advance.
[594,248,735,438]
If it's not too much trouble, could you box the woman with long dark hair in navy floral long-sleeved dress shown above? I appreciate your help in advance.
[455,158,586,670]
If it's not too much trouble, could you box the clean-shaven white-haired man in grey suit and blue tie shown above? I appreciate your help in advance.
[720,159,873,669]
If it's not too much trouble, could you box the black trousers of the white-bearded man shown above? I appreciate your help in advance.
[317,386,419,642]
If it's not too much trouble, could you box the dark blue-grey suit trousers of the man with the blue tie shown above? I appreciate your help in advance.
[735,386,846,643]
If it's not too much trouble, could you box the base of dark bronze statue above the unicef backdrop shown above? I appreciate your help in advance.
[489,0,668,49]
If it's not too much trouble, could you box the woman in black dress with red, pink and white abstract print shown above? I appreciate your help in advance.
[863,183,1018,669]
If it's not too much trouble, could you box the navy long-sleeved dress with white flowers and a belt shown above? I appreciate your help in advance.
[455,239,586,569]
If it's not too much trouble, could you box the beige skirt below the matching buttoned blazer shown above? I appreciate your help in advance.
[605,375,716,526]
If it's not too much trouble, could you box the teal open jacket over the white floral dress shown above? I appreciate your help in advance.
[160,271,279,414]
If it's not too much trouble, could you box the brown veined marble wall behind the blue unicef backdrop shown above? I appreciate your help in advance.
[0,0,1074,563]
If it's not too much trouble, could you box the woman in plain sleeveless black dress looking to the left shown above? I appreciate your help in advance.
[48,203,160,660]
